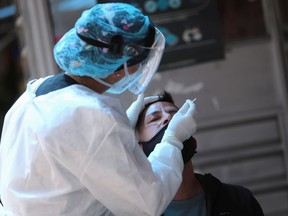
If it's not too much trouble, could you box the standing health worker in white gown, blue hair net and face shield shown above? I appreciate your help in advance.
[0,3,196,216]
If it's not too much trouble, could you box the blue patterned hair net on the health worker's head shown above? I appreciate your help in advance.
[54,3,151,78]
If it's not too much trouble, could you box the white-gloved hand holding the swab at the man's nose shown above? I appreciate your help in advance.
[161,100,197,150]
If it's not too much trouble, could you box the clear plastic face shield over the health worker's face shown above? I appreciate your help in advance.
[95,28,165,94]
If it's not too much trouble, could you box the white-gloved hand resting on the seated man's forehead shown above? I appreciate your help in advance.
[126,93,159,128]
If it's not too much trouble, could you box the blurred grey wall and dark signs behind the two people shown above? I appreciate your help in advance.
[0,0,288,216]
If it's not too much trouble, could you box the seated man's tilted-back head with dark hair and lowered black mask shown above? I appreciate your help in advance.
[136,91,197,163]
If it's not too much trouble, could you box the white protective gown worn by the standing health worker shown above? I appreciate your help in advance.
[0,79,183,216]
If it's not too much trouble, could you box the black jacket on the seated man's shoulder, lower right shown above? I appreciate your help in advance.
[196,174,264,216]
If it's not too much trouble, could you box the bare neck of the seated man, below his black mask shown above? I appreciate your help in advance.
[173,162,202,201]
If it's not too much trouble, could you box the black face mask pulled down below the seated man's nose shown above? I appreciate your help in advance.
[139,125,196,164]
